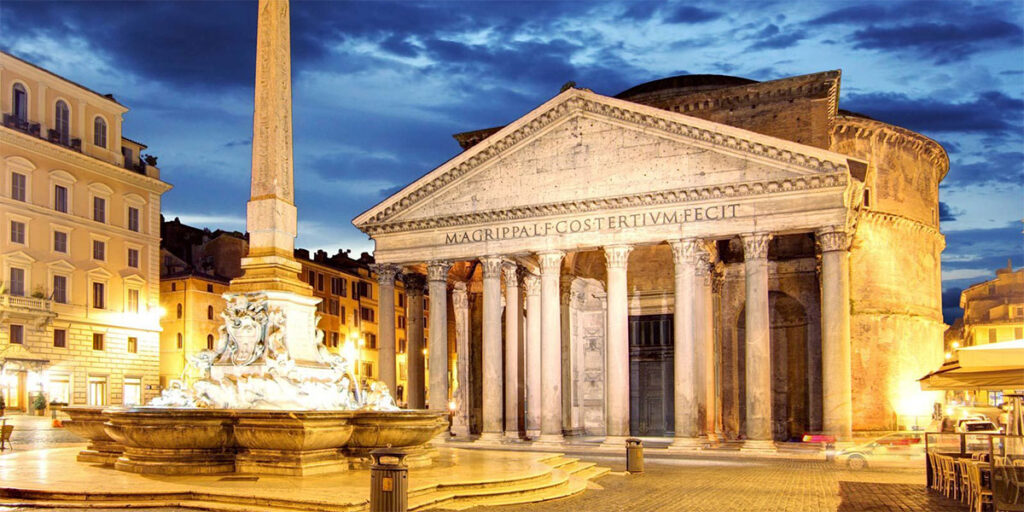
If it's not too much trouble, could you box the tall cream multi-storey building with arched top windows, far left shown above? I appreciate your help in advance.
[0,52,170,410]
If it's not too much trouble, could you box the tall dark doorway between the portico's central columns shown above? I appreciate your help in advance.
[630,314,675,436]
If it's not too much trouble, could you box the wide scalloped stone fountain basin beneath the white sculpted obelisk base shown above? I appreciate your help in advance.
[65,407,447,475]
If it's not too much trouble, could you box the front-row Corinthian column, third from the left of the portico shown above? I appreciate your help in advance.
[480,256,503,441]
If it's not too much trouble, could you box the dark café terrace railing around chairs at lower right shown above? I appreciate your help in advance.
[925,432,1024,512]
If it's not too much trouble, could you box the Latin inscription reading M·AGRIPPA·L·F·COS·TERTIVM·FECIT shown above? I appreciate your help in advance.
[444,205,739,245]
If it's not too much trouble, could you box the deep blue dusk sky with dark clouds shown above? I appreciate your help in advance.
[0,0,1024,321]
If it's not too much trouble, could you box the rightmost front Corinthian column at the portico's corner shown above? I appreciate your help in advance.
[817,227,853,440]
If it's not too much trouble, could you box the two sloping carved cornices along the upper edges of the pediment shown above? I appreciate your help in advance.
[352,89,849,234]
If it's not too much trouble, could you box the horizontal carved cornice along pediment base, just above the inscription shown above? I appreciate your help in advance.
[360,172,850,236]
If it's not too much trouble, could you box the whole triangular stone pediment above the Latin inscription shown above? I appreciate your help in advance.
[353,89,849,230]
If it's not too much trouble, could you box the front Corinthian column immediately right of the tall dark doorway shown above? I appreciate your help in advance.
[669,239,700,450]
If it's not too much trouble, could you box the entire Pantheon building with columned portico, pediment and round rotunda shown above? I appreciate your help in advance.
[353,71,948,450]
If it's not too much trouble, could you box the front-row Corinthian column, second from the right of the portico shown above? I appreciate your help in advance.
[742,232,775,451]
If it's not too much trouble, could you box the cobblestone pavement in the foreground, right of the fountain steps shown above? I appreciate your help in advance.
[460,458,967,512]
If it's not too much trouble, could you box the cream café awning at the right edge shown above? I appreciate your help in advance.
[919,340,1024,391]
